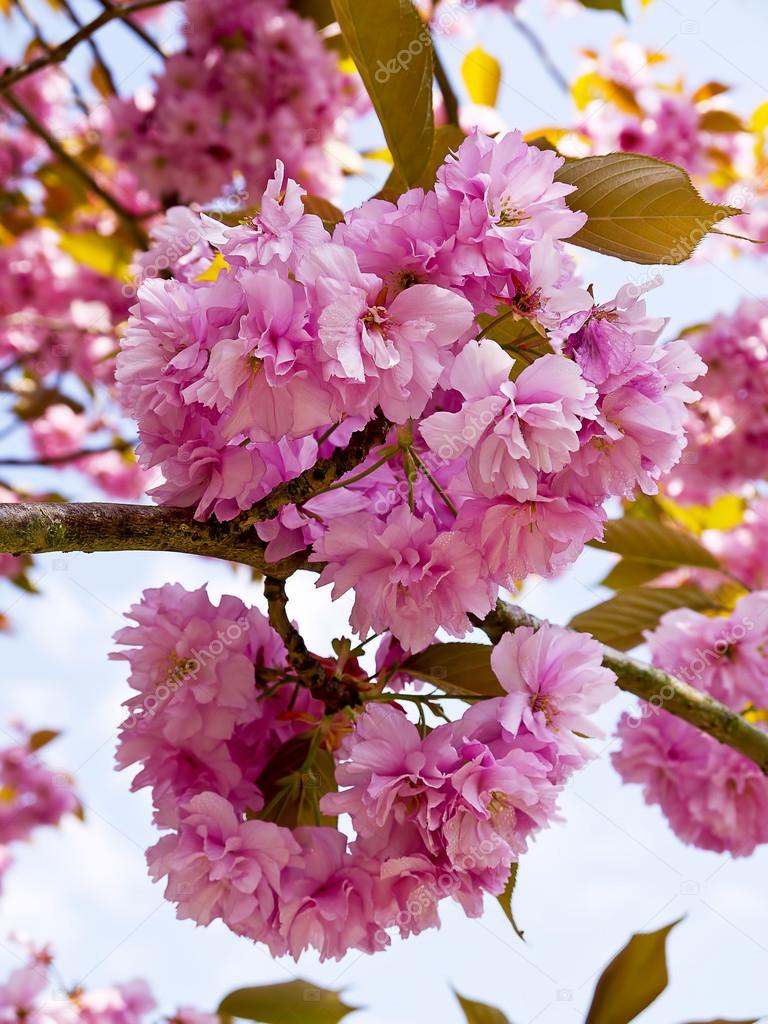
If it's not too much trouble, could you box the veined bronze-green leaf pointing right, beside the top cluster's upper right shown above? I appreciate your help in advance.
[555,153,740,264]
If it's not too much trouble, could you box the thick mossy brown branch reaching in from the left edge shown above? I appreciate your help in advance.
[0,502,309,579]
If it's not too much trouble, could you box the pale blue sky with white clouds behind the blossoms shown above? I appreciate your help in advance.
[0,0,768,1024]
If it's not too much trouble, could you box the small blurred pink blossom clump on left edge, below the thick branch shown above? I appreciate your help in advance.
[0,724,80,877]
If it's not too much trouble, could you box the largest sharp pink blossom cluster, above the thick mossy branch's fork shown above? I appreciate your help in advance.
[123,132,702,650]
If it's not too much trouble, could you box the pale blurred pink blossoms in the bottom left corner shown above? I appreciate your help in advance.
[0,940,218,1024]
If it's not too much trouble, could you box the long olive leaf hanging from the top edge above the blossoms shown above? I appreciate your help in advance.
[332,0,434,185]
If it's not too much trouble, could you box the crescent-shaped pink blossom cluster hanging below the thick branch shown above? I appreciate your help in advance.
[114,585,614,957]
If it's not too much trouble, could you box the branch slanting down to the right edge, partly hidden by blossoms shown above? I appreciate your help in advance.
[472,601,768,774]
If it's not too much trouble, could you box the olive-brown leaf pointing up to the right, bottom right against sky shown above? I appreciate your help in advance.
[585,921,680,1024]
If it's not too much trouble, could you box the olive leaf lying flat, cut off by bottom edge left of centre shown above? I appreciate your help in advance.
[218,980,358,1024]
